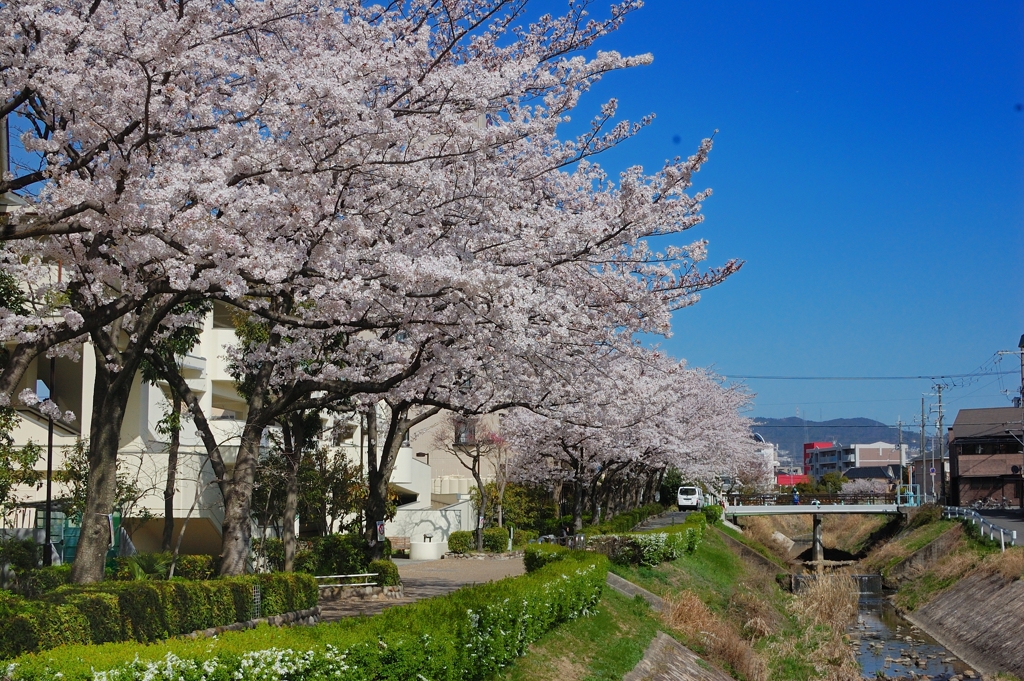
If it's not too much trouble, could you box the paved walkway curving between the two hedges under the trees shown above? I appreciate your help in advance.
[319,558,526,622]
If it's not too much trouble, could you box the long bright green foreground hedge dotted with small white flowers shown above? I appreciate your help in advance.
[8,552,607,681]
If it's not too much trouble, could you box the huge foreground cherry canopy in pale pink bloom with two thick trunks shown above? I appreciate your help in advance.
[0,0,739,582]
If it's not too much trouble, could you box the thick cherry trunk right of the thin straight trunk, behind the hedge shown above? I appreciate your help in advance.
[220,419,263,577]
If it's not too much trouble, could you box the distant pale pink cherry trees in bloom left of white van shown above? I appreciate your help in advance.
[503,348,754,529]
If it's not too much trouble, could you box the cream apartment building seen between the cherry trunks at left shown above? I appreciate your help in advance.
[2,303,473,556]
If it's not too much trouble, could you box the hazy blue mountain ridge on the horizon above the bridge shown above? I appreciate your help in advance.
[753,416,921,463]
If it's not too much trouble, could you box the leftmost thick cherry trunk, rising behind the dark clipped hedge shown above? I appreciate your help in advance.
[71,348,137,584]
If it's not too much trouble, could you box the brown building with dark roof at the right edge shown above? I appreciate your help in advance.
[949,407,1024,506]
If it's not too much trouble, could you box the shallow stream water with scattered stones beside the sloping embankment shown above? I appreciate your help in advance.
[849,576,978,681]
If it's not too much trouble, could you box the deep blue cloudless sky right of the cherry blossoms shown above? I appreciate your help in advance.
[577,0,1024,423]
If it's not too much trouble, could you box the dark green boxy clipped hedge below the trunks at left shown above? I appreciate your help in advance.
[0,572,317,658]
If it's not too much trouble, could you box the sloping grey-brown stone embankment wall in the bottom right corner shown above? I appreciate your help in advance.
[904,574,1024,677]
